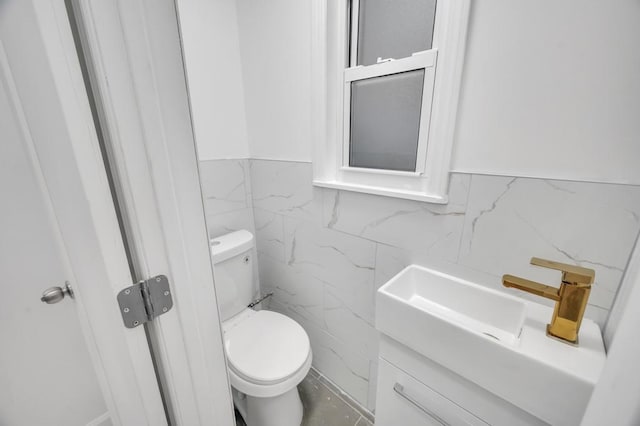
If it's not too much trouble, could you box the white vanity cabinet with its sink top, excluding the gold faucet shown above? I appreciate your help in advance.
[376,265,606,426]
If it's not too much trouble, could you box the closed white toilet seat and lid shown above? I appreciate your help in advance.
[223,309,311,397]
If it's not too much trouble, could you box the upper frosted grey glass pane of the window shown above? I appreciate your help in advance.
[357,0,436,65]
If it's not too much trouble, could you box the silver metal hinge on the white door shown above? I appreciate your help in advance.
[118,275,173,328]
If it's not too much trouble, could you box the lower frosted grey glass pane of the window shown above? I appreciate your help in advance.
[349,69,424,171]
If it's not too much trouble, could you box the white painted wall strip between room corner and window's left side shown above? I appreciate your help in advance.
[237,0,311,161]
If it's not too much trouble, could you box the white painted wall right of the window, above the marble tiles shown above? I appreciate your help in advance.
[453,0,640,184]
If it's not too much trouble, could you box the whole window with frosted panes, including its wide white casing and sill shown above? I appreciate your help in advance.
[312,0,469,203]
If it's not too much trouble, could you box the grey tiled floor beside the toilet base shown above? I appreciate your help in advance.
[236,370,372,426]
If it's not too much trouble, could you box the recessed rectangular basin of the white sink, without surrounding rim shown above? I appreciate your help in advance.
[379,265,525,345]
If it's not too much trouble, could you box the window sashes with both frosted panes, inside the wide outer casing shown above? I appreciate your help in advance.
[344,0,436,173]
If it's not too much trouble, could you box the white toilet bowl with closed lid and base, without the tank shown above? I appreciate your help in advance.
[223,309,311,426]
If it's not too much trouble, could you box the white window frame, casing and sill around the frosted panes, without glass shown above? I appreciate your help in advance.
[311,0,470,204]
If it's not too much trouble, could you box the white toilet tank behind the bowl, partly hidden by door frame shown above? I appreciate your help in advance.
[210,230,255,321]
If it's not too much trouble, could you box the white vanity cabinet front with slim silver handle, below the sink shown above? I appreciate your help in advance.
[376,359,487,426]
